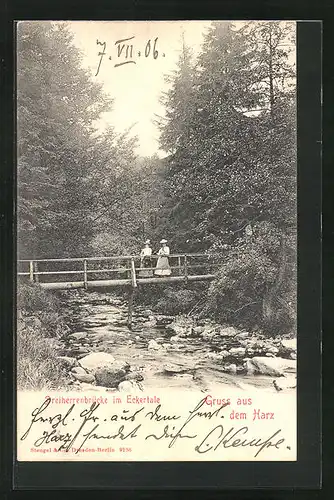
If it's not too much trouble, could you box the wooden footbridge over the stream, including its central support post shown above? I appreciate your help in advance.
[18,253,217,327]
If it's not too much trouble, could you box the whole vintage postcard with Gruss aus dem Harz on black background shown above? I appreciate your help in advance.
[16,20,297,460]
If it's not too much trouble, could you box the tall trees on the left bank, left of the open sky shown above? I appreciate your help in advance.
[17,21,112,258]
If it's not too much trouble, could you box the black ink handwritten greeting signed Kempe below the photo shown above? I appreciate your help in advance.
[20,398,285,457]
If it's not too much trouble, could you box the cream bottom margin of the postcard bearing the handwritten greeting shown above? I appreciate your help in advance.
[18,394,295,460]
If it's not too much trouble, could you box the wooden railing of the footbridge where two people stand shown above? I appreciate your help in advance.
[18,253,217,288]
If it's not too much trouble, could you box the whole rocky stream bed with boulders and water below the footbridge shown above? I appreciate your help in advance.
[55,290,296,392]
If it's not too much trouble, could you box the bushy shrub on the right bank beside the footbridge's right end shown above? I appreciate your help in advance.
[203,224,296,335]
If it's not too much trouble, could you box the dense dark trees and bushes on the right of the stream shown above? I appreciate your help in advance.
[155,22,296,333]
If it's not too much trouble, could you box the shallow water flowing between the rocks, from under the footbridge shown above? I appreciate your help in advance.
[58,291,292,392]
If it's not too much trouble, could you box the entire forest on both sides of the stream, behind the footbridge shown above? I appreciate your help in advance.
[17,21,297,335]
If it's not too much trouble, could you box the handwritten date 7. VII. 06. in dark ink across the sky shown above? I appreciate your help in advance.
[95,36,165,76]
